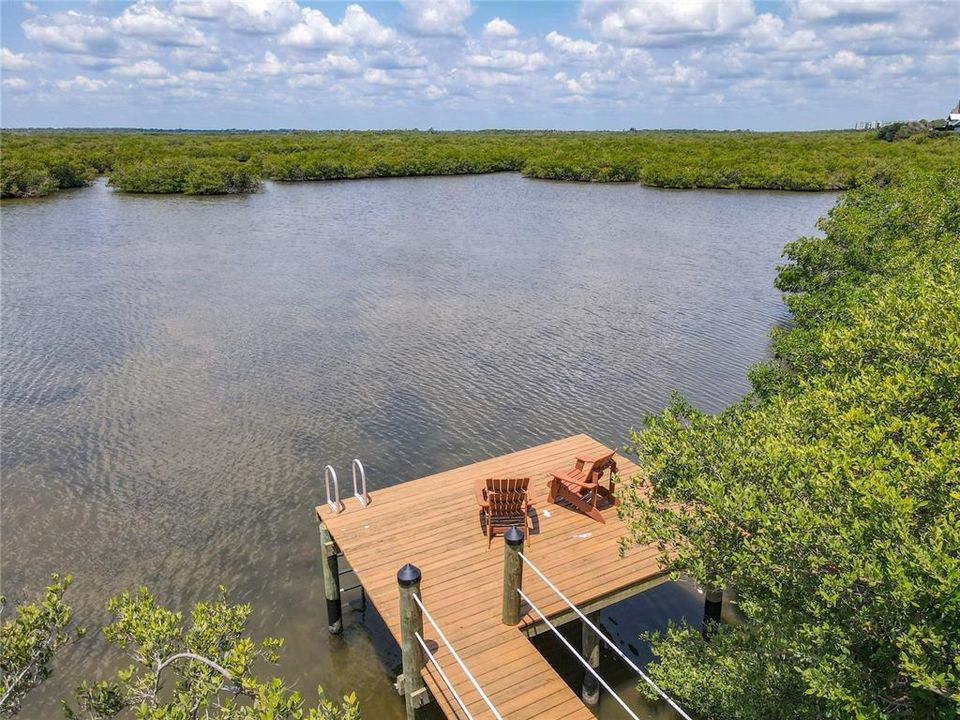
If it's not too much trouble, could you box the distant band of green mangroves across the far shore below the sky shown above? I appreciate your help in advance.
[0,126,960,197]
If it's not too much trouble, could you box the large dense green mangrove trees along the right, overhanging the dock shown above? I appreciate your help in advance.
[623,175,960,719]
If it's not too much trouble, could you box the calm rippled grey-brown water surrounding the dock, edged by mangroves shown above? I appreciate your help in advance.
[0,174,835,720]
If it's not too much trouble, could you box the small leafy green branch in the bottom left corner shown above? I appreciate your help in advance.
[0,574,83,717]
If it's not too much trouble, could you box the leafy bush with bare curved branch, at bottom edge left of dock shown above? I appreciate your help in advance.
[64,587,360,720]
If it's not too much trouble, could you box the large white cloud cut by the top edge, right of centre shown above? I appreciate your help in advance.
[580,0,754,46]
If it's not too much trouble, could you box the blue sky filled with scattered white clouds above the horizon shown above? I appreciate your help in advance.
[0,0,960,130]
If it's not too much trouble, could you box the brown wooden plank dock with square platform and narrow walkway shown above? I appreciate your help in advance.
[316,435,666,720]
